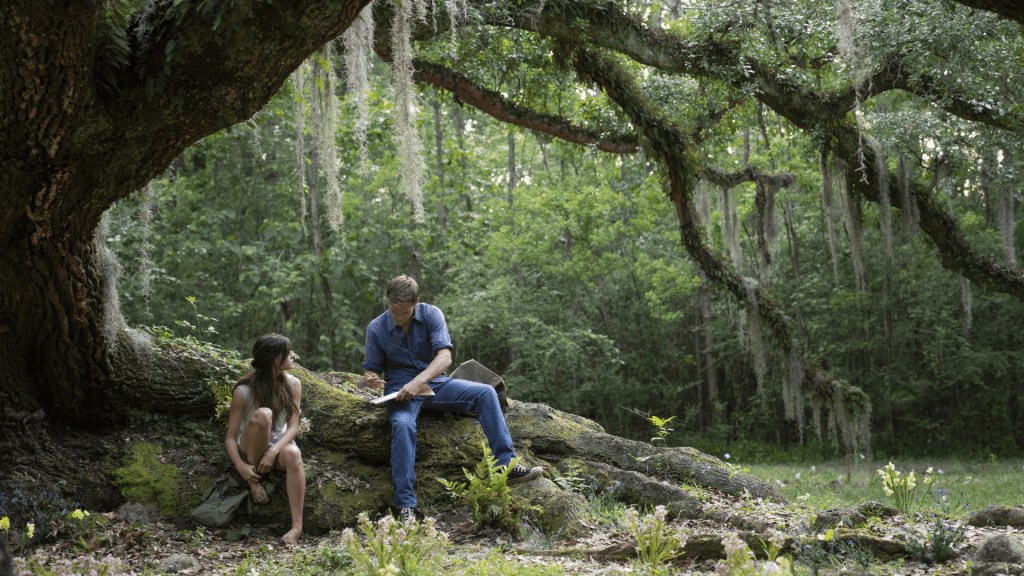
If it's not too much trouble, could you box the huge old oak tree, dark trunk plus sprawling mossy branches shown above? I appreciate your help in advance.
[0,0,1024,448]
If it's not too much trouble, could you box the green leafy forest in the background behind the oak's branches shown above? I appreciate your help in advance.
[99,2,1024,462]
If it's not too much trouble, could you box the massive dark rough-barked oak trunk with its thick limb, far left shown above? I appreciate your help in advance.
[0,0,367,422]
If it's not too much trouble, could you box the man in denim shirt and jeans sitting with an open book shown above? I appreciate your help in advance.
[362,276,543,522]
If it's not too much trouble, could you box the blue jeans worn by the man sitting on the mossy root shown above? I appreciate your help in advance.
[385,379,515,508]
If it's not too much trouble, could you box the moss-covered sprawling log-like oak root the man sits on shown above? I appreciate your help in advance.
[97,347,784,535]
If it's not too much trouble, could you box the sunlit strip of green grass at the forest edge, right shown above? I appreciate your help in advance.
[742,459,1024,518]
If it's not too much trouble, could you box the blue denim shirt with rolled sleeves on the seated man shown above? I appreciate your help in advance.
[362,302,455,390]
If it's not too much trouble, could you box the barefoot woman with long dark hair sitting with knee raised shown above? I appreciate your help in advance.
[224,334,306,544]
